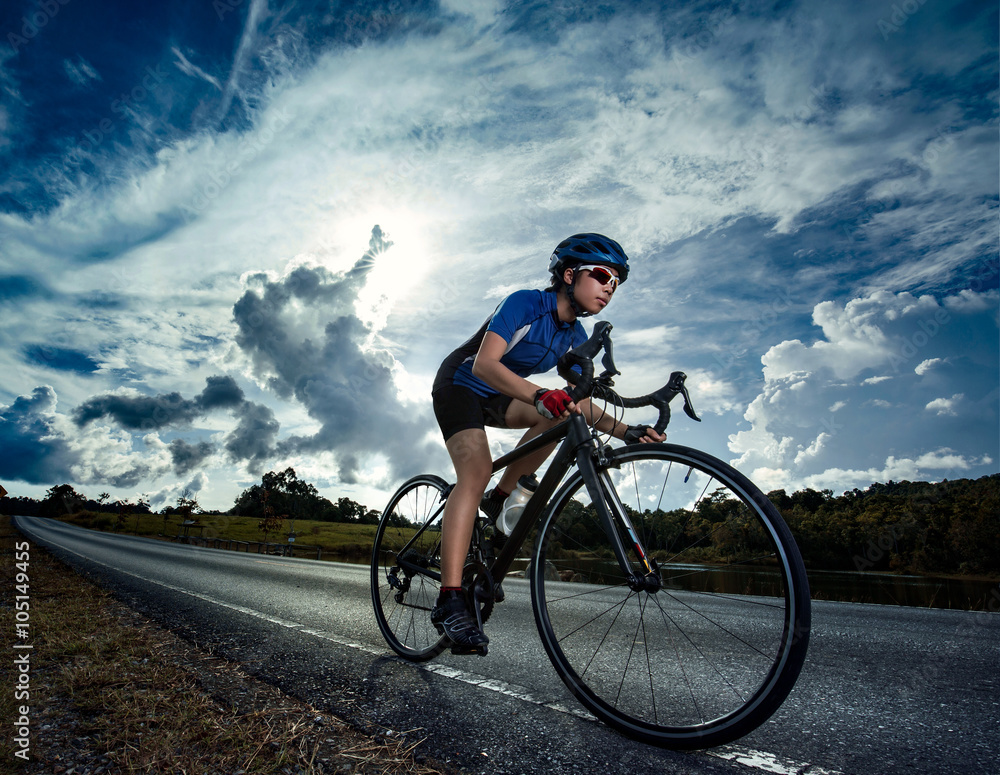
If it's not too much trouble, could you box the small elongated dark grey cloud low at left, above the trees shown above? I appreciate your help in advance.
[73,376,245,431]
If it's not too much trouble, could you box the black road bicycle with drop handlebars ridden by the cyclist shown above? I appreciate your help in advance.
[371,321,810,748]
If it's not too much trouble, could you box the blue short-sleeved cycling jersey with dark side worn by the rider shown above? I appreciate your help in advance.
[434,291,587,397]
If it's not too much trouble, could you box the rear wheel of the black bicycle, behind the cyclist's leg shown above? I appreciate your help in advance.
[371,474,449,662]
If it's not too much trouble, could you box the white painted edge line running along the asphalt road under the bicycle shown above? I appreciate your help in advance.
[19,520,842,775]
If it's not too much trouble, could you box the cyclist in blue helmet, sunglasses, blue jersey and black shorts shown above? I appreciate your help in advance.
[431,233,666,651]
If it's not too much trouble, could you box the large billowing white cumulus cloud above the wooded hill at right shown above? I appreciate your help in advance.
[729,291,996,489]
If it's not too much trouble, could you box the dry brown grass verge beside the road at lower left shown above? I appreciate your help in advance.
[0,518,452,775]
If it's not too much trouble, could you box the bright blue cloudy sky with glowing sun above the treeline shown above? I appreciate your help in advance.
[0,0,1000,510]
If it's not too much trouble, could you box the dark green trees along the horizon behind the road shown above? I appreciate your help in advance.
[0,468,1000,578]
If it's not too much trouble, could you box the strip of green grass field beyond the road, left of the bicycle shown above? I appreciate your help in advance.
[62,512,375,562]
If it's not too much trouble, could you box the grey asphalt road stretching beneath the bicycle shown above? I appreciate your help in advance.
[15,517,1000,775]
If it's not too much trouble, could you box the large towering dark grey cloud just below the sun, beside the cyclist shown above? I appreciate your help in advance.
[233,226,433,483]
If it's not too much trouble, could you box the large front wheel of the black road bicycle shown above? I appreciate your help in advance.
[531,444,810,748]
